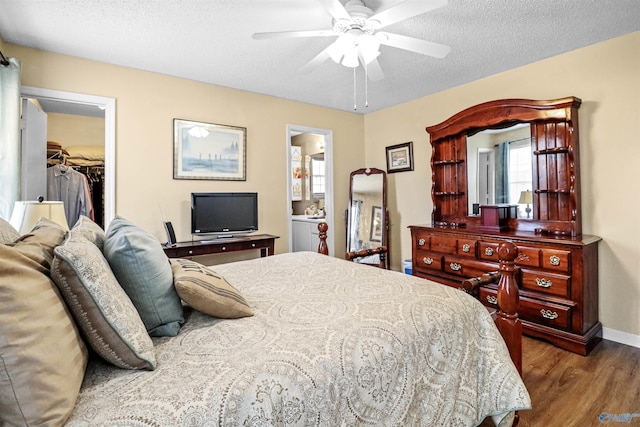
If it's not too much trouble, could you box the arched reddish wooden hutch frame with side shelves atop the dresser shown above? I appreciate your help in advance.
[426,97,582,237]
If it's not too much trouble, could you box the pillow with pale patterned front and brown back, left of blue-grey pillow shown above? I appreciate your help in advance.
[51,231,156,370]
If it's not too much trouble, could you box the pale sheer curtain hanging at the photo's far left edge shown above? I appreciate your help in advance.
[0,58,21,221]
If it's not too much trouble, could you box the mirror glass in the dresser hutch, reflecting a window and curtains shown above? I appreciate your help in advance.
[467,123,533,219]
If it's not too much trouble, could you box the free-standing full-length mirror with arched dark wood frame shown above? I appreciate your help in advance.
[347,168,388,268]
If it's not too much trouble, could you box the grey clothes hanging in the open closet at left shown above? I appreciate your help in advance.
[47,164,94,227]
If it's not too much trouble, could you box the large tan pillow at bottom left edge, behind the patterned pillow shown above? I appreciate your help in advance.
[0,220,88,426]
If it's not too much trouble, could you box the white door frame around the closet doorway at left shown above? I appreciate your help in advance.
[20,86,116,230]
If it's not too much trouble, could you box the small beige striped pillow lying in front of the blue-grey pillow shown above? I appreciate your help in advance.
[171,259,253,319]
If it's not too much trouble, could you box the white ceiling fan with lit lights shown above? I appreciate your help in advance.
[253,0,451,81]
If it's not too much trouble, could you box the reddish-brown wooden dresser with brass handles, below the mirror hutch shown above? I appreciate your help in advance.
[410,225,602,355]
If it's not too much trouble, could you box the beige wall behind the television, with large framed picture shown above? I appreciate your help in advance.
[6,44,364,254]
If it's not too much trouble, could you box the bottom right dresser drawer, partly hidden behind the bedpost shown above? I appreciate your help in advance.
[479,286,571,329]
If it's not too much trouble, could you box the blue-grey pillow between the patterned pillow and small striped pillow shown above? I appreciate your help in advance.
[104,217,184,337]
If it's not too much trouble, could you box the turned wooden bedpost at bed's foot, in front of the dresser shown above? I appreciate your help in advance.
[496,242,522,376]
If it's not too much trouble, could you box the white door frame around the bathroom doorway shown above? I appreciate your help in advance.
[286,124,336,256]
